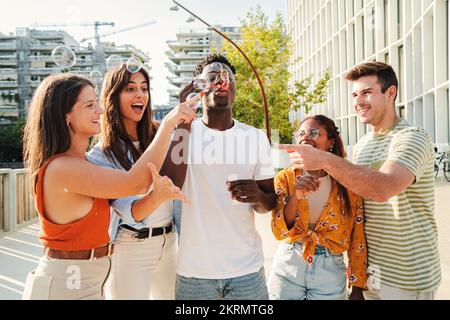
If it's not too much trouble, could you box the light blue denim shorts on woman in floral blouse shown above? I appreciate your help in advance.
[268,242,347,300]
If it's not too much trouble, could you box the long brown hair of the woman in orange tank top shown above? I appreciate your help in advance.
[23,73,94,194]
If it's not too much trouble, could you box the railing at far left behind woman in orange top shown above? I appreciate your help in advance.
[0,169,38,234]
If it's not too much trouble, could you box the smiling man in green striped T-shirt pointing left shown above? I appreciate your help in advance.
[281,62,441,300]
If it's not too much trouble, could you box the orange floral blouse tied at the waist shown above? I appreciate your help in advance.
[272,167,367,288]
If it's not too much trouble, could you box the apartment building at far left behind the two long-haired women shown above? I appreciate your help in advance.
[0,28,151,119]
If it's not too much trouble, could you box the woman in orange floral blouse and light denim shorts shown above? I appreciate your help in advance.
[268,115,367,300]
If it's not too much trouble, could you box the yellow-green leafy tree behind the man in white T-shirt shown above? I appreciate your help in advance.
[223,6,331,143]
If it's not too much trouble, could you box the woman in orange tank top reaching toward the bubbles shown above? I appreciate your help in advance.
[23,74,195,299]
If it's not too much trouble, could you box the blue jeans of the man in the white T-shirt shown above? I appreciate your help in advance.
[175,267,269,300]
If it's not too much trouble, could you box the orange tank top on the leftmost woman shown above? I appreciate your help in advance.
[36,155,110,251]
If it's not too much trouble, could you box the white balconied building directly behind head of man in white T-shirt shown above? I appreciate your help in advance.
[166,26,241,106]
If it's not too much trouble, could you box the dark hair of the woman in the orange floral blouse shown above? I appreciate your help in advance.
[300,114,351,213]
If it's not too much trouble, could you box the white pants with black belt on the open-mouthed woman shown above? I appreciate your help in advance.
[105,228,178,300]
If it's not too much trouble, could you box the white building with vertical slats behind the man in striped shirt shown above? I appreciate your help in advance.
[286,0,450,152]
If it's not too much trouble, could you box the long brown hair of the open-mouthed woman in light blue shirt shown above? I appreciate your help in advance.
[100,65,158,170]
